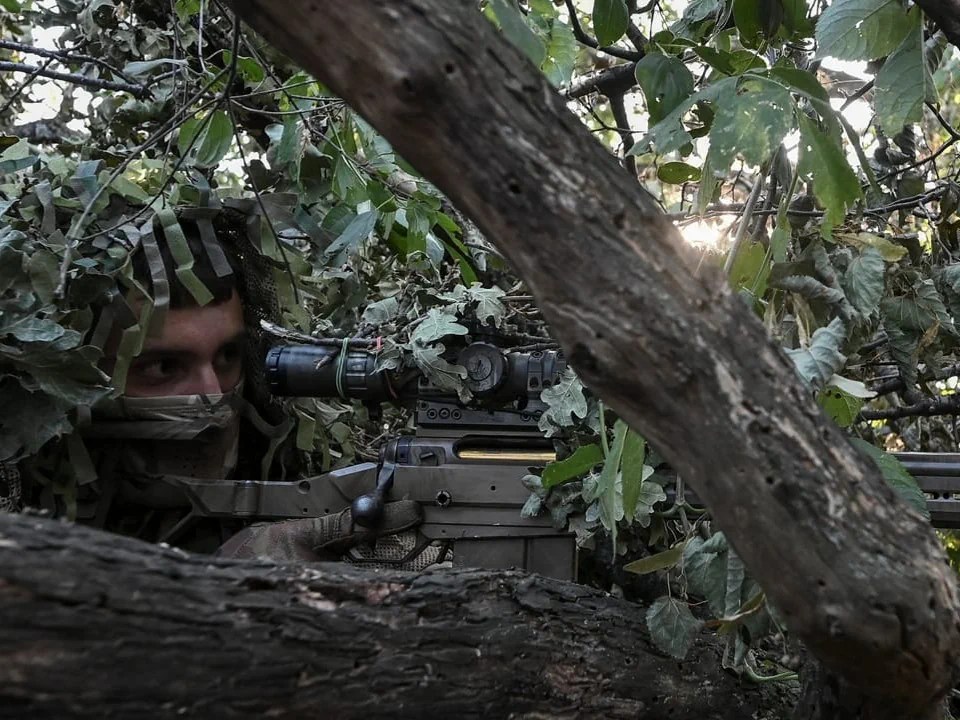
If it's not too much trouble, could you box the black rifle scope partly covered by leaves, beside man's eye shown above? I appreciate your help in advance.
[266,342,566,403]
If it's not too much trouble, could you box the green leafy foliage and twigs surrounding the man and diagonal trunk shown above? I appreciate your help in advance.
[0,0,960,688]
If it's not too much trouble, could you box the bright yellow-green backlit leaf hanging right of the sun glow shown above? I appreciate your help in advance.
[798,114,862,238]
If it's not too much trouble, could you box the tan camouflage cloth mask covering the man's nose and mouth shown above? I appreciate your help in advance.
[83,386,242,509]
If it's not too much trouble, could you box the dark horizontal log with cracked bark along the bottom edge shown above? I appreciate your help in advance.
[0,515,792,720]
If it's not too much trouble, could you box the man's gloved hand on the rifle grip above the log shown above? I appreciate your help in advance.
[215,500,423,562]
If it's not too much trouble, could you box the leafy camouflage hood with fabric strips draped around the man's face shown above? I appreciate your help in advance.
[0,172,312,520]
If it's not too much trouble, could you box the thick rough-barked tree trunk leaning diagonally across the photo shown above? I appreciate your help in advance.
[225,0,960,718]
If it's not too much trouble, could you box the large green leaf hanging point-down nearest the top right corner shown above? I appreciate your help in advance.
[874,14,937,137]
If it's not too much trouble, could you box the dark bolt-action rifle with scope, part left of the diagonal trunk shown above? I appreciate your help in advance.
[183,342,577,580]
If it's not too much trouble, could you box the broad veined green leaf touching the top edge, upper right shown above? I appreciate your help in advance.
[816,0,914,60]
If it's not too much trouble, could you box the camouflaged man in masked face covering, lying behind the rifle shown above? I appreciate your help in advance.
[0,208,426,569]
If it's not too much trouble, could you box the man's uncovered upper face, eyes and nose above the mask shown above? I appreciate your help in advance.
[124,293,244,397]
